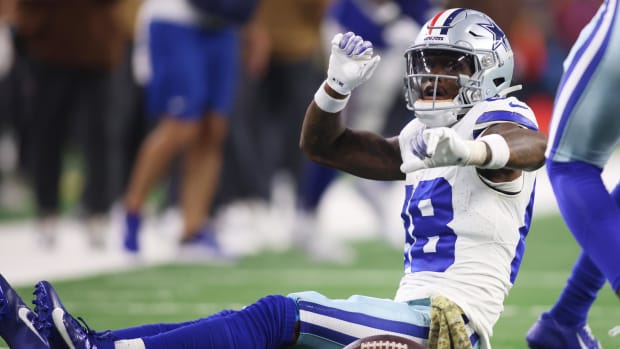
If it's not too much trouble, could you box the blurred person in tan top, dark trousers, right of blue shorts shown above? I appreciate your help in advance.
[216,0,329,253]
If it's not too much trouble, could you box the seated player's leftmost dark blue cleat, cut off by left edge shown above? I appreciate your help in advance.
[0,275,49,349]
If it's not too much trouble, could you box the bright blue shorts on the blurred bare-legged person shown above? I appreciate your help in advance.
[147,21,239,120]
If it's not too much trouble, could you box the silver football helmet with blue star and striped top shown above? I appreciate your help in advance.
[405,8,520,126]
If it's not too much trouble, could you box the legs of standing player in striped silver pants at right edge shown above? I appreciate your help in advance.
[526,0,620,349]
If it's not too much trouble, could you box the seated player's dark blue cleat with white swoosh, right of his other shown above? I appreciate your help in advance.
[33,281,105,349]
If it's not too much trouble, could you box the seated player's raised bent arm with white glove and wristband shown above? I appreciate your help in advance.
[300,32,404,179]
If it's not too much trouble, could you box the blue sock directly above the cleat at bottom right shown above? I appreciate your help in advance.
[550,253,605,327]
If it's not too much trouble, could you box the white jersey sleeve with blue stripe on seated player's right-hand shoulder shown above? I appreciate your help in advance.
[473,97,538,139]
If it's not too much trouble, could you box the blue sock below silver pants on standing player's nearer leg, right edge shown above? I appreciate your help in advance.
[547,161,620,290]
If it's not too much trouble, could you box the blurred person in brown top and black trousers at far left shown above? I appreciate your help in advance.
[15,0,126,246]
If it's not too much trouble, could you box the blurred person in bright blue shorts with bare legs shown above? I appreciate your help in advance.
[124,0,254,259]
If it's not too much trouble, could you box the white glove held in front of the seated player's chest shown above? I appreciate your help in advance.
[400,127,487,173]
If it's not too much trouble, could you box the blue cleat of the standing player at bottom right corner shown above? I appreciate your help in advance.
[525,313,603,349]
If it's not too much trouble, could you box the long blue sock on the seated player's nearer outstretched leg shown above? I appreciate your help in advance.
[142,296,297,349]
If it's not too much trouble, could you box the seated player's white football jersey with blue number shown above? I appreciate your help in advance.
[395,97,538,347]
